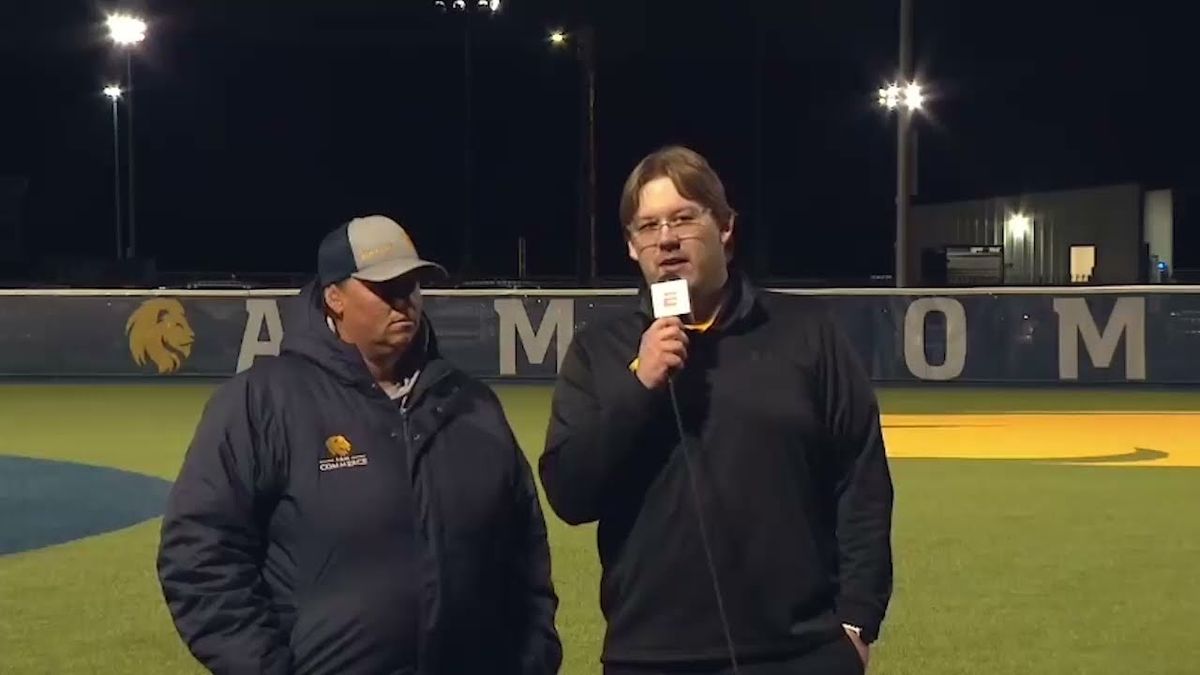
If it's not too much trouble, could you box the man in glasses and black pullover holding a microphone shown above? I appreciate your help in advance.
[539,147,893,675]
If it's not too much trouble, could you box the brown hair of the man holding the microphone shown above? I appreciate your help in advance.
[618,145,737,235]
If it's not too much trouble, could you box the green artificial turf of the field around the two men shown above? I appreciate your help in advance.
[0,383,1200,675]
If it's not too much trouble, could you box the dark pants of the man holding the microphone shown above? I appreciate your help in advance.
[604,638,865,675]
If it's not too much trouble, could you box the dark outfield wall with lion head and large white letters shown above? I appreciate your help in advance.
[0,286,1200,384]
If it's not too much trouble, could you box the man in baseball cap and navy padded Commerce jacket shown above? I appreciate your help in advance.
[158,216,562,675]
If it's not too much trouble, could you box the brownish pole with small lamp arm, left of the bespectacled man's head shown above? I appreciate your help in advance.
[546,25,599,286]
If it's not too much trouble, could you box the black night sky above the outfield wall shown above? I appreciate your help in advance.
[0,0,1200,280]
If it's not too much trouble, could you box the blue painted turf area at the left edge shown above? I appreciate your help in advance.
[0,456,170,555]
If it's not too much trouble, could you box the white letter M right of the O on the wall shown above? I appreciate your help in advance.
[1054,297,1146,380]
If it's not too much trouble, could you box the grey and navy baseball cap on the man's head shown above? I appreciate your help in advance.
[317,216,449,286]
